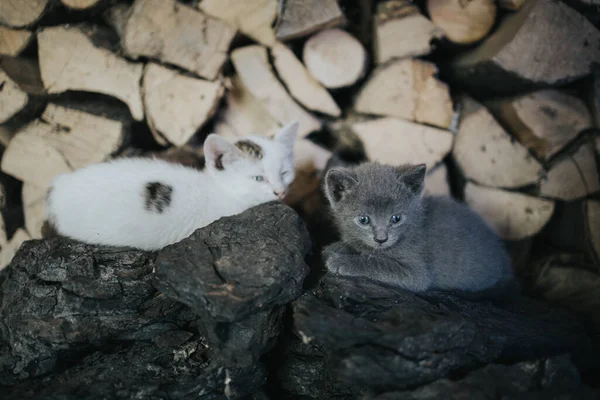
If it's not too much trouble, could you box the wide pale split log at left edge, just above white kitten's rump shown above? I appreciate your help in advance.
[2,104,126,188]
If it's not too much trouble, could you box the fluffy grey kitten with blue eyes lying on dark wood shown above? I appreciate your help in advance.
[323,163,512,292]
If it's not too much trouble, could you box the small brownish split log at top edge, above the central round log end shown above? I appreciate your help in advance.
[275,0,346,41]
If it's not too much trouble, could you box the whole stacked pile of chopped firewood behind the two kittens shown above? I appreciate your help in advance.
[0,0,600,288]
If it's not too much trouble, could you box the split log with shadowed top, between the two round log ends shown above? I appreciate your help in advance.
[375,0,444,64]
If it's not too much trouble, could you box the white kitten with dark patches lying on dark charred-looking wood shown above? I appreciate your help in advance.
[47,122,298,250]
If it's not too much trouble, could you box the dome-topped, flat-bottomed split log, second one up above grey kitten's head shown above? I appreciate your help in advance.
[354,59,453,128]
